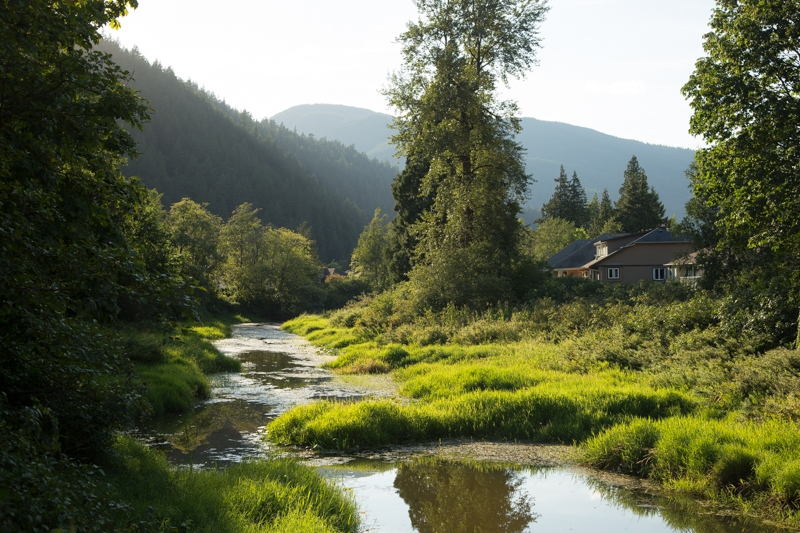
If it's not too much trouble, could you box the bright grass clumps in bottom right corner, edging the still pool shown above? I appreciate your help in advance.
[580,417,800,524]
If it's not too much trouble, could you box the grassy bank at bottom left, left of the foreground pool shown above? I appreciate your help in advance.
[105,438,358,533]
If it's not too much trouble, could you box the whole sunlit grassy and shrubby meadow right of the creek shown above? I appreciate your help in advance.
[268,285,800,525]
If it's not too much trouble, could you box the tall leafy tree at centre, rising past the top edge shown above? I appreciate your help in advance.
[386,0,546,306]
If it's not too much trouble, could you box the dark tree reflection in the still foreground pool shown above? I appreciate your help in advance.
[394,459,536,533]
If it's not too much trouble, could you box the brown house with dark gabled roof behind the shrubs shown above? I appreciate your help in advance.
[547,228,697,283]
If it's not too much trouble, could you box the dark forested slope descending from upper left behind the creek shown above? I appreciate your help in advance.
[99,41,397,262]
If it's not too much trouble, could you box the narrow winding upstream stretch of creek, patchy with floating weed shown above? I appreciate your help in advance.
[138,324,361,466]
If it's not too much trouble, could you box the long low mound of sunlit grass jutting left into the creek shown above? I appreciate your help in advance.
[268,383,694,449]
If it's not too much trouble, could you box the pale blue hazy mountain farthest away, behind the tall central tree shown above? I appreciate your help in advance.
[272,104,694,221]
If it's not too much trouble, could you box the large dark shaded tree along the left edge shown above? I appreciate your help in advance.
[0,0,155,454]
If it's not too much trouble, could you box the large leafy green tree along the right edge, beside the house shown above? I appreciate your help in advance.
[683,0,800,344]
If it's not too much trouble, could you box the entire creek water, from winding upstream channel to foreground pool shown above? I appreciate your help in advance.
[139,324,778,533]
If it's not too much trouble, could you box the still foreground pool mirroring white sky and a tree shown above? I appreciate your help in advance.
[322,458,778,533]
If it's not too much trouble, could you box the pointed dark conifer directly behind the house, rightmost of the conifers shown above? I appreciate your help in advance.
[614,156,666,233]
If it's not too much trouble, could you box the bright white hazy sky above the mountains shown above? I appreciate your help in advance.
[108,0,714,148]
